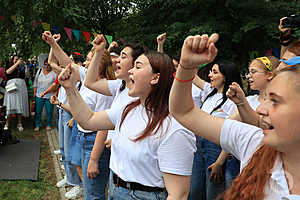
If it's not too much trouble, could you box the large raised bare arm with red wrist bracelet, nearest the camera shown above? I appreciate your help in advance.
[169,34,224,144]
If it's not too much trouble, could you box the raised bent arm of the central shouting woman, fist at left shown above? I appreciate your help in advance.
[58,65,114,131]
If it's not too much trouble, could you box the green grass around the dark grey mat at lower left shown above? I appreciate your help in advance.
[0,116,60,200]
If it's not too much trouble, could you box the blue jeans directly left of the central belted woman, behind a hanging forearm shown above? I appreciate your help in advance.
[78,131,110,200]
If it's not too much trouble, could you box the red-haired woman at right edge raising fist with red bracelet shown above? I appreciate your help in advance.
[169,34,300,200]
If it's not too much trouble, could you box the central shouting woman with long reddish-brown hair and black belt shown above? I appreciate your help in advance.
[59,35,196,199]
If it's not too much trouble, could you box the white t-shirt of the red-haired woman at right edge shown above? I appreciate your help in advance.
[220,120,300,200]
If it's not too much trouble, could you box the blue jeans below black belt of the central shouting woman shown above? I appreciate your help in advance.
[111,184,168,200]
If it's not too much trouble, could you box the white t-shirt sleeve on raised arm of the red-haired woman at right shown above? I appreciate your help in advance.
[220,119,263,160]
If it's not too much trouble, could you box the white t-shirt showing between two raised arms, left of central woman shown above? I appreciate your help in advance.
[77,79,114,133]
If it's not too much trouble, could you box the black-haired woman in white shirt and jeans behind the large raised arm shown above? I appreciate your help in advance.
[190,60,242,200]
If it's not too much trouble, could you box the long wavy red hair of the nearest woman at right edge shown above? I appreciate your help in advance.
[220,65,300,200]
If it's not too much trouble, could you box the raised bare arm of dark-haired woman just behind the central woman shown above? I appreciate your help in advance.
[84,35,112,96]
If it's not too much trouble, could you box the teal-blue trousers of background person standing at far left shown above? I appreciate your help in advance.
[35,97,54,127]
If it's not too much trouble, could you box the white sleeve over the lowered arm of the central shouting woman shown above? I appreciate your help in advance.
[158,129,196,176]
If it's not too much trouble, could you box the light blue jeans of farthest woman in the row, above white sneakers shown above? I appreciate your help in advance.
[58,109,81,185]
